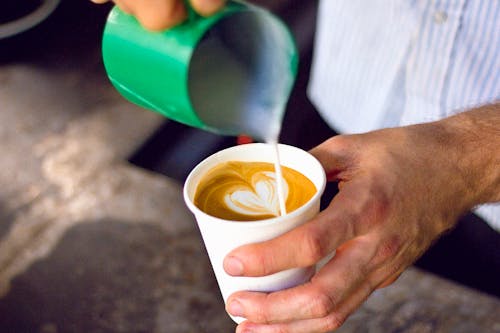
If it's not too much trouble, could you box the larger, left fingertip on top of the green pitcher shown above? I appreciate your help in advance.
[127,0,187,31]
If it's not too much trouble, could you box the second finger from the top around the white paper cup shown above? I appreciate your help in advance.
[227,237,376,324]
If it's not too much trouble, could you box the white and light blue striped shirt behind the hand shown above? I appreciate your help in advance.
[309,0,500,231]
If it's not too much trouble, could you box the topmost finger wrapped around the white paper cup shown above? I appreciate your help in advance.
[224,193,356,276]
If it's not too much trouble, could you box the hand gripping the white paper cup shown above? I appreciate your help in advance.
[224,107,499,333]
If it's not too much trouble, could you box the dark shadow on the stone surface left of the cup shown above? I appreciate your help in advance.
[0,220,234,333]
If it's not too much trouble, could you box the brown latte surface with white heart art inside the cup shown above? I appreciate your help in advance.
[194,161,316,221]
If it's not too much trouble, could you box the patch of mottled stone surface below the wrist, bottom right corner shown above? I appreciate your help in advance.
[337,268,500,333]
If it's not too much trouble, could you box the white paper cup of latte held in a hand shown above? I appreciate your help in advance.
[184,143,326,323]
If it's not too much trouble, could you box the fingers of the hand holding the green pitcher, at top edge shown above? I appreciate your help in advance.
[91,0,226,31]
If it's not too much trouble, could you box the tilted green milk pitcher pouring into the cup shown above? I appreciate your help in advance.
[102,1,298,141]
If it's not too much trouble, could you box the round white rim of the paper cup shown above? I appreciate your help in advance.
[183,143,326,227]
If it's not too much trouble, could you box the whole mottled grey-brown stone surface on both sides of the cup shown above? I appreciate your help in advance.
[0,0,500,333]
